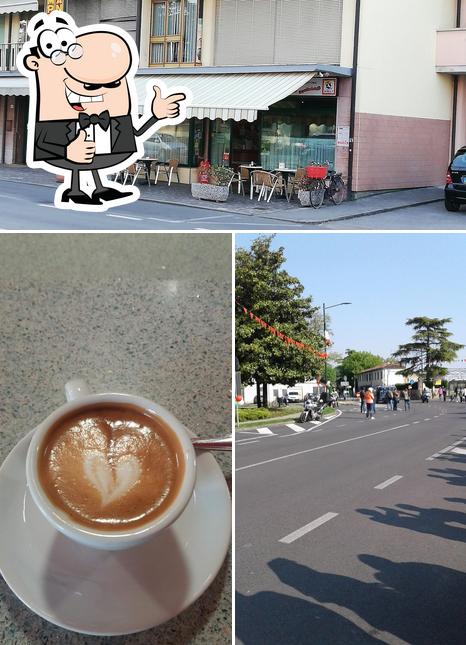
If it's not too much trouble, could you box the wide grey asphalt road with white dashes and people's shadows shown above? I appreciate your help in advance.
[236,402,466,645]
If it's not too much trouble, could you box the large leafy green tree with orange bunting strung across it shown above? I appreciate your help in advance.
[236,235,324,406]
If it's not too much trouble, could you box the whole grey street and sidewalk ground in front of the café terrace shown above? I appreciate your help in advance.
[0,166,456,231]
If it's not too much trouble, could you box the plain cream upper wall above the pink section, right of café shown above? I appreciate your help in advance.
[356,0,456,119]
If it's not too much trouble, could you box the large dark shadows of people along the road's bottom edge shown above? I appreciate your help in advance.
[236,554,466,645]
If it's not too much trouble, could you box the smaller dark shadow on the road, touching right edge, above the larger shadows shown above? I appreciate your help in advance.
[356,504,466,542]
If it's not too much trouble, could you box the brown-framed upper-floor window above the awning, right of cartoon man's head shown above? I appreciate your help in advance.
[150,0,203,66]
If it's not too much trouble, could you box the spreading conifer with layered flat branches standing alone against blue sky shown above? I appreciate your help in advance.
[394,316,464,387]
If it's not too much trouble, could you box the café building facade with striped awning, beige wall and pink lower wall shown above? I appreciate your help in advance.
[0,0,466,195]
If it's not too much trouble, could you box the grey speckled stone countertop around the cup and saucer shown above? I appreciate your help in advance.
[0,233,231,645]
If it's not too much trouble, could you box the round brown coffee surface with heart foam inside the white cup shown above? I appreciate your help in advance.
[38,404,184,530]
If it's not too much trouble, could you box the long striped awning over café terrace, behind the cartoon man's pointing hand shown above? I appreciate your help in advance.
[136,72,315,121]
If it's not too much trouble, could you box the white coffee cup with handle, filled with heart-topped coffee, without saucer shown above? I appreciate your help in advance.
[26,380,196,550]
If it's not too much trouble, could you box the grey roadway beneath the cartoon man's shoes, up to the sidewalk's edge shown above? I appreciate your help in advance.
[0,180,301,231]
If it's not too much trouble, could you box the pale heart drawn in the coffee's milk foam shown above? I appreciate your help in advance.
[84,452,141,506]
